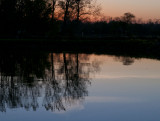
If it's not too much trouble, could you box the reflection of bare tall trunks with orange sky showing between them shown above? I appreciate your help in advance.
[43,53,100,111]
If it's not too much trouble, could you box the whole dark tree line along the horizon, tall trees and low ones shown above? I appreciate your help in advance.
[0,0,160,39]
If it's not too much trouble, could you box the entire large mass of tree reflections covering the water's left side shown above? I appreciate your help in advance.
[0,53,98,112]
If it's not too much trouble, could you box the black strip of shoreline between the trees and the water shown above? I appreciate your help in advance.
[0,39,160,59]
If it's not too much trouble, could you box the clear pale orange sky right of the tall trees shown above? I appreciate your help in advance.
[97,0,160,20]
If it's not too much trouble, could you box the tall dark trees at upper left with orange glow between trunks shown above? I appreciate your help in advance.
[0,0,98,37]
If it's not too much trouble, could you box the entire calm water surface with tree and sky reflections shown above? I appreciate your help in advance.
[0,53,160,121]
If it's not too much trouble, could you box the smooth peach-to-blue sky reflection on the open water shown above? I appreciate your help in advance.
[0,55,160,121]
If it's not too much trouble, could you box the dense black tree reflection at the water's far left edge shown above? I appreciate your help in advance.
[0,53,49,111]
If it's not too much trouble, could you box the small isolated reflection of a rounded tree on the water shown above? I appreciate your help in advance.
[115,56,135,65]
